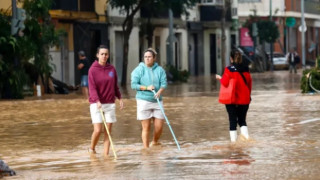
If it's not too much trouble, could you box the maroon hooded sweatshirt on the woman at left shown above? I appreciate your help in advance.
[89,61,121,104]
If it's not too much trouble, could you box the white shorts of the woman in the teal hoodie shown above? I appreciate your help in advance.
[137,99,164,120]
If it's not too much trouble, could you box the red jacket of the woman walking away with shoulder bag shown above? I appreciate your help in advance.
[220,65,252,105]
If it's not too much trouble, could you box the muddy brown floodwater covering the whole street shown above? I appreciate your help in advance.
[0,71,320,180]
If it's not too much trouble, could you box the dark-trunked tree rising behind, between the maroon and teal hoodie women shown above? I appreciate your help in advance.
[107,0,197,86]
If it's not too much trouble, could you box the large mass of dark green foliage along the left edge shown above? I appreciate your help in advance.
[0,0,58,98]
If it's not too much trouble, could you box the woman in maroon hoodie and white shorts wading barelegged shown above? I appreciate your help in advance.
[88,45,123,156]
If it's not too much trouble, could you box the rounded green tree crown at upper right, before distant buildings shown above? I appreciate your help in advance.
[245,16,280,43]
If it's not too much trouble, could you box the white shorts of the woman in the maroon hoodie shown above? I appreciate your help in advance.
[90,103,117,124]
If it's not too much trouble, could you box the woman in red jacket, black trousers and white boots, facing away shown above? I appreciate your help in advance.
[216,49,252,142]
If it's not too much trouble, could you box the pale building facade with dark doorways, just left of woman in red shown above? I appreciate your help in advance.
[188,0,239,75]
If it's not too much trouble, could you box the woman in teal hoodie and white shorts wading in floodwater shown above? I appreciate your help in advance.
[131,48,167,148]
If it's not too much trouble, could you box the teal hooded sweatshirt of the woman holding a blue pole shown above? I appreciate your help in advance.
[131,62,167,102]
